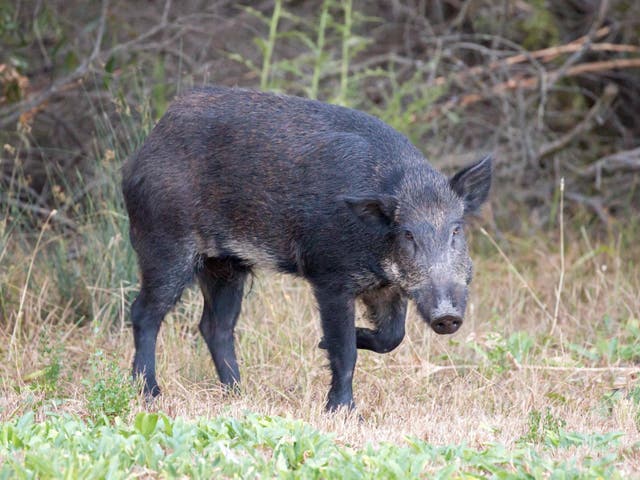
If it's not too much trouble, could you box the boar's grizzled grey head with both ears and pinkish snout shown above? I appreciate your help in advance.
[345,156,491,334]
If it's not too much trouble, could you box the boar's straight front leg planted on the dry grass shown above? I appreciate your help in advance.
[315,286,357,411]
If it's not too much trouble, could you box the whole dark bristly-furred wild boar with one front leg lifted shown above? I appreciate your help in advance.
[123,87,491,409]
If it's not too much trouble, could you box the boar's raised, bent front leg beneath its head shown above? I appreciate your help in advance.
[356,288,407,353]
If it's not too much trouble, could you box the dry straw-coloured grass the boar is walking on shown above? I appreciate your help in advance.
[0,219,640,469]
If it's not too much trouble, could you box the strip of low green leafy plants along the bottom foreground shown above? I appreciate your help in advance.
[0,413,626,479]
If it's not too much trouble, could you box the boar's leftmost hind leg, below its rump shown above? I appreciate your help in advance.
[131,255,193,397]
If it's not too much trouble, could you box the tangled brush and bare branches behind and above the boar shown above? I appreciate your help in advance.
[0,0,640,224]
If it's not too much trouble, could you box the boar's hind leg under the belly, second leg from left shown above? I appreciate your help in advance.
[198,258,249,388]
